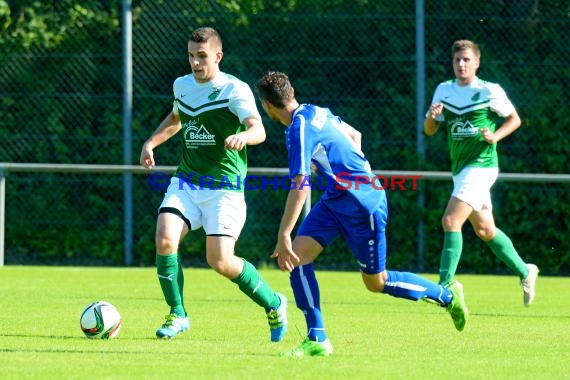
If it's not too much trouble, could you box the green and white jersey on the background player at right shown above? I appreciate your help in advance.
[426,77,515,175]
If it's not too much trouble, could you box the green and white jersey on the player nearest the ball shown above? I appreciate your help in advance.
[169,72,261,191]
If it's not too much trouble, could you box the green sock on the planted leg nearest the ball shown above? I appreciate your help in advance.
[156,252,186,317]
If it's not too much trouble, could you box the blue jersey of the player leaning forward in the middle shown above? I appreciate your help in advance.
[285,104,386,215]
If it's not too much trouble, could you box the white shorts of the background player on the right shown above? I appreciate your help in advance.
[451,166,499,211]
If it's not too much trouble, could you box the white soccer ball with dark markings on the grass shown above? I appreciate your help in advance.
[79,301,121,339]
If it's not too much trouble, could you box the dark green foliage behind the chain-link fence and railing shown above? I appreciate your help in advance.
[0,0,570,274]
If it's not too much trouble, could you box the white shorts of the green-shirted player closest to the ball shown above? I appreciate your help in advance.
[159,177,246,240]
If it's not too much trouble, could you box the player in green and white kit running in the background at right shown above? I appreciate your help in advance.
[424,40,538,306]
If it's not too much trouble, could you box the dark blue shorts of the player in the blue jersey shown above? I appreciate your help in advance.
[297,201,388,274]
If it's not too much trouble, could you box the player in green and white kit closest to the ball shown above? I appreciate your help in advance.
[140,27,287,342]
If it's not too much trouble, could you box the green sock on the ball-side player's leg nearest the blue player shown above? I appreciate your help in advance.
[232,259,281,310]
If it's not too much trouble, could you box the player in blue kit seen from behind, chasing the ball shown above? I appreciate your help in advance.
[255,71,468,356]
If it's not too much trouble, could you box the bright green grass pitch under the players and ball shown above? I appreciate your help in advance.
[0,266,570,380]
